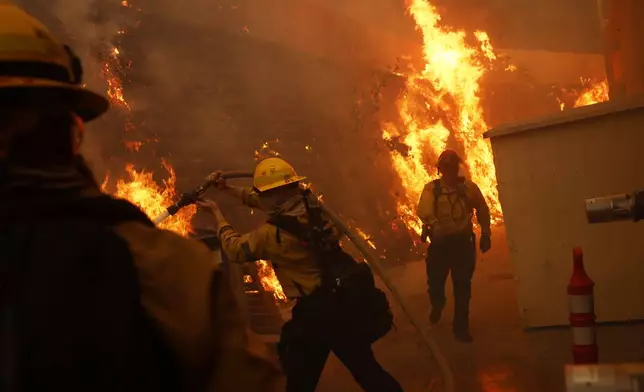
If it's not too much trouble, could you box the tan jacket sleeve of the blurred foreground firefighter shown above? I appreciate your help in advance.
[115,222,284,392]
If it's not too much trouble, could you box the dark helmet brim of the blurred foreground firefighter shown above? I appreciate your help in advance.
[0,78,110,122]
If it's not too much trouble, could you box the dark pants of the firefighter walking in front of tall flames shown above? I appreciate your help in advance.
[427,233,476,333]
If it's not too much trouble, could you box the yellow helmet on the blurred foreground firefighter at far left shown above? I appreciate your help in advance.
[0,0,109,121]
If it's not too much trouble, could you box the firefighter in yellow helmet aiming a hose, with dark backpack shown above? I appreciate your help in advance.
[199,158,402,392]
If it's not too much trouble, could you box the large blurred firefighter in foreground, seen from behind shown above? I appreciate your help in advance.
[0,0,281,392]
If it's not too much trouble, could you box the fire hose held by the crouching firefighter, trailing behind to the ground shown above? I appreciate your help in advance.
[154,171,454,392]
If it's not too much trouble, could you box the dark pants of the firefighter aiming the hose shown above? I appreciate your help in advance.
[280,298,402,392]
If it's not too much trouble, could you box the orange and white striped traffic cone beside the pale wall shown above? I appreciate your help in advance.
[568,248,598,364]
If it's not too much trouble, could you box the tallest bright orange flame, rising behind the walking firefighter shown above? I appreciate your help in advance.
[383,0,503,234]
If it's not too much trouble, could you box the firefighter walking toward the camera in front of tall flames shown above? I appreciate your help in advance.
[418,150,491,342]
